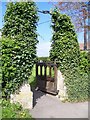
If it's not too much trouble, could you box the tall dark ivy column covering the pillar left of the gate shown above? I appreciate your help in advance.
[2,1,38,96]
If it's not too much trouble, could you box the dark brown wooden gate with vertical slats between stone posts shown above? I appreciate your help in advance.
[36,62,58,95]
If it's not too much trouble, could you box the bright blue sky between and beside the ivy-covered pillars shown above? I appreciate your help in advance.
[0,2,83,56]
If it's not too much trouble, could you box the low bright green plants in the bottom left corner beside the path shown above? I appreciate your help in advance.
[0,100,34,120]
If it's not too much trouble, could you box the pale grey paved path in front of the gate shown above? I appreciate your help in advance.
[30,91,88,118]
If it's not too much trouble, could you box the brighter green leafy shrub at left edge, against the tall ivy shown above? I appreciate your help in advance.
[0,38,20,96]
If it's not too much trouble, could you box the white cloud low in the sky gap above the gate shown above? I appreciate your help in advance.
[37,42,51,57]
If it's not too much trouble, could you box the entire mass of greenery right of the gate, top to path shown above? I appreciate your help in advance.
[50,9,90,101]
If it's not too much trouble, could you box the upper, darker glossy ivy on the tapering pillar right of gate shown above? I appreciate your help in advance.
[50,9,80,71]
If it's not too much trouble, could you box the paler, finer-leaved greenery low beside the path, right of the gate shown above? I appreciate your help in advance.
[64,68,90,102]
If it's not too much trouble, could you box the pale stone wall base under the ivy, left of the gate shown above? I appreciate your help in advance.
[10,83,33,109]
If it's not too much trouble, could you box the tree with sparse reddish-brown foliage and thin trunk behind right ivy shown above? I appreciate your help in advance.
[50,2,90,50]
